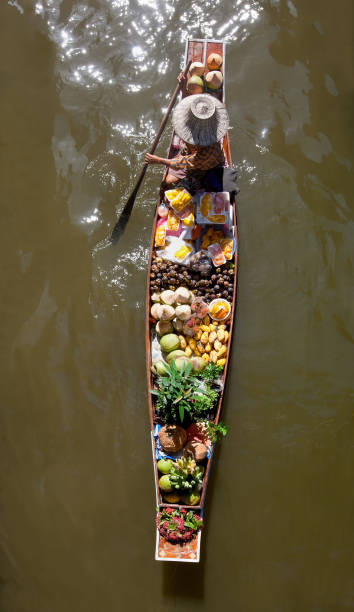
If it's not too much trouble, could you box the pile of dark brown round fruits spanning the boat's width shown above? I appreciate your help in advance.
[150,253,234,301]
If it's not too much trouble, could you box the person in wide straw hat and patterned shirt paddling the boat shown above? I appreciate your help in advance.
[145,94,229,185]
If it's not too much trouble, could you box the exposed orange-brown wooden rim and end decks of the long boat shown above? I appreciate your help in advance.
[146,40,238,563]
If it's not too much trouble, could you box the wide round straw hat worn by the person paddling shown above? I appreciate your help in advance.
[172,94,229,147]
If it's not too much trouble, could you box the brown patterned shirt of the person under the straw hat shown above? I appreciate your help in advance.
[170,142,225,172]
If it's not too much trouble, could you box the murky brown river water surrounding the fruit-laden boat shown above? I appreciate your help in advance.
[0,0,354,612]
